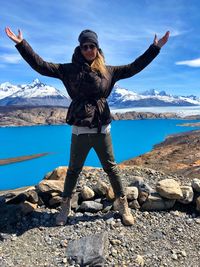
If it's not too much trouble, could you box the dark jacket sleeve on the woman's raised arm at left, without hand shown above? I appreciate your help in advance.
[15,39,63,79]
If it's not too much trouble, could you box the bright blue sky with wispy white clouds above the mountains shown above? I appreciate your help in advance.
[0,0,200,96]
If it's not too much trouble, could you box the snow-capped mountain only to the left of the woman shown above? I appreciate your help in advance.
[0,79,71,107]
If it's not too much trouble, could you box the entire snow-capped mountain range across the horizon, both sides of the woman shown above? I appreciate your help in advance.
[0,79,200,108]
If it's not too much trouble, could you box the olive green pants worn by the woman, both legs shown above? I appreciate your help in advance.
[63,133,124,197]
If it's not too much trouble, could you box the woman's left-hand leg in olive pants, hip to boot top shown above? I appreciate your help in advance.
[63,134,91,198]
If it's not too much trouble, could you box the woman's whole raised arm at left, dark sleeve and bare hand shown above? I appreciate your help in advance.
[5,27,63,79]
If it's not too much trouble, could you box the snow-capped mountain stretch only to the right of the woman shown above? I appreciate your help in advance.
[108,85,200,108]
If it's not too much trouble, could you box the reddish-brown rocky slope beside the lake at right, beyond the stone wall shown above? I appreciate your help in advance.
[122,130,200,178]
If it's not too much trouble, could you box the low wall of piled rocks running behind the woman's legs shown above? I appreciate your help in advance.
[2,166,200,219]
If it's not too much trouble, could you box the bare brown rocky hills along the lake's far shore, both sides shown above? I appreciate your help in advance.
[0,106,183,126]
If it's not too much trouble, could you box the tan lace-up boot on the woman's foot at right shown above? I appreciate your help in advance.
[114,196,134,225]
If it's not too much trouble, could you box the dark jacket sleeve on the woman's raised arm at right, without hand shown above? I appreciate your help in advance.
[112,44,160,84]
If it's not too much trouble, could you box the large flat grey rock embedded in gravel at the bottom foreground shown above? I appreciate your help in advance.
[66,233,108,266]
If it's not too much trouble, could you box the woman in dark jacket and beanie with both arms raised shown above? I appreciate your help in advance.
[5,27,169,225]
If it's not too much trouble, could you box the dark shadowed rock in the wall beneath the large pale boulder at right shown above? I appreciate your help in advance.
[141,193,176,211]
